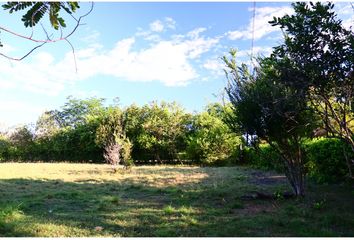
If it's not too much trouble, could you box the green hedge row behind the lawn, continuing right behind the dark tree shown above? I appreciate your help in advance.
[0,94,354,182]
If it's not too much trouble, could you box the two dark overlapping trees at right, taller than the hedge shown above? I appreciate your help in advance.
[223,2,354,195]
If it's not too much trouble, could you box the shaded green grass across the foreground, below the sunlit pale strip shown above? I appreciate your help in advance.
[0,169,354,237]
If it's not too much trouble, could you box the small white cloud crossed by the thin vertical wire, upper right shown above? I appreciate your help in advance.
[226,7,293,40]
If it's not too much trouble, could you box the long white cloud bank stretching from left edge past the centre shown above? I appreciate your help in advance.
[0,25,220,96]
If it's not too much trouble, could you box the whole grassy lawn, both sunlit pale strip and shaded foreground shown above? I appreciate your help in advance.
[0,163,354,237]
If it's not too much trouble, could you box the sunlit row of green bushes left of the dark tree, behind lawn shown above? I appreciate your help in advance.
[0,97,242,164]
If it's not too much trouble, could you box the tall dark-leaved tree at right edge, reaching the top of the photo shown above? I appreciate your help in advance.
[270,2,354,177]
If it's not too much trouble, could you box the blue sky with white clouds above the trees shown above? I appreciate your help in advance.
[0,2,354,127]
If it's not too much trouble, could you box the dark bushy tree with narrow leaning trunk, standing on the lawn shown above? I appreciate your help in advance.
[223,50,313,196]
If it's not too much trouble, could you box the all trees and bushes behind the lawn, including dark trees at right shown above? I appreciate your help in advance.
[0,2,354,196]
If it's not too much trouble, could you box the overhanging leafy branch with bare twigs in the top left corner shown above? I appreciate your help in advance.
[0,2,93,61]
